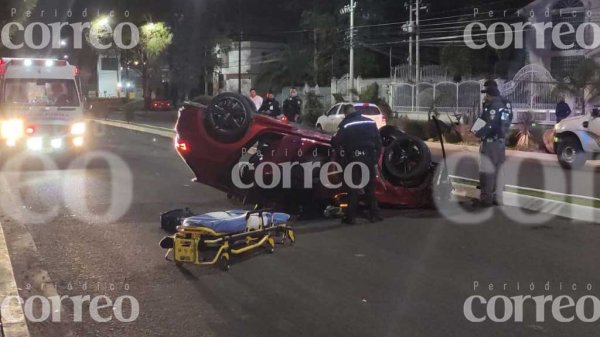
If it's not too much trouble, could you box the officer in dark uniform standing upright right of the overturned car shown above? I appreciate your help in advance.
[475,86,507,207]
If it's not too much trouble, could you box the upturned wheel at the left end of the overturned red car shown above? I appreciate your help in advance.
[204,93,256,143]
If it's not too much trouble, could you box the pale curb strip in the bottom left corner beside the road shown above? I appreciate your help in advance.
[0,220,30,337]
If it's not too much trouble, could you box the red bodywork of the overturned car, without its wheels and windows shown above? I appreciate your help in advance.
[175,97,442,208]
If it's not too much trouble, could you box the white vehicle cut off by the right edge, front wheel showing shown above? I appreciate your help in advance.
[554,108,600,169]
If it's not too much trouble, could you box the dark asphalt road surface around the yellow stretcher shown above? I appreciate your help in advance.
[0,127,600,337]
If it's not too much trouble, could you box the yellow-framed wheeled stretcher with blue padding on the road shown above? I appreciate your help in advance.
[160,210,296,270]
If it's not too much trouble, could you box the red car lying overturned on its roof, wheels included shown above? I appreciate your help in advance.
[175,93,447,212]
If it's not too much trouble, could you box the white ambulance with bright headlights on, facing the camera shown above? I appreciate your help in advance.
[0,58,86,152]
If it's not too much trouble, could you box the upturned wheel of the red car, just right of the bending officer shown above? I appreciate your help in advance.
[383,134,431,182]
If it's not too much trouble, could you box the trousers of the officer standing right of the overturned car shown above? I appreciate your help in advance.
[479,139,506,205]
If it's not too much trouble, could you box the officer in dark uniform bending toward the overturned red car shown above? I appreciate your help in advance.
[331,104,383,224]
